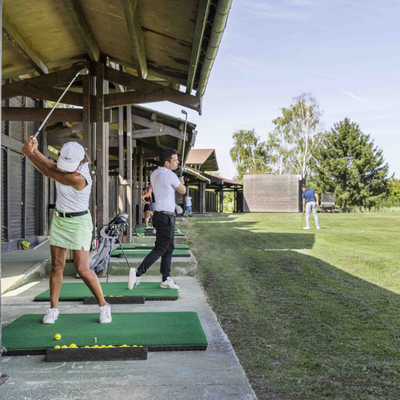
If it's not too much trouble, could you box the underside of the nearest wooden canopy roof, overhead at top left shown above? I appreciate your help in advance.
[2,0,232,103]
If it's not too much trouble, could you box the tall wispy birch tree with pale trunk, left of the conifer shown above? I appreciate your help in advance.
[268,93,324,178]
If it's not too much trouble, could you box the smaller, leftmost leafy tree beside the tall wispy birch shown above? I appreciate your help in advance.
[230,129,271,181]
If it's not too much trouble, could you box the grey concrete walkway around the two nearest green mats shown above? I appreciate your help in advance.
[0,276,256,400]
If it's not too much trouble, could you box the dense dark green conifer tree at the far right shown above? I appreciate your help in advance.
[311,118,389,211]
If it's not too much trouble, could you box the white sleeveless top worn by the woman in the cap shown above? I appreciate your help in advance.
[56,163,92,212]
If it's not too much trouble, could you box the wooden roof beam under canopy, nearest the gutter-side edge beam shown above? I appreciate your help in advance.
[122,0,147,79]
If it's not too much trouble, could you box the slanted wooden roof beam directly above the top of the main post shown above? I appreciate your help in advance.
[62,0,100,61]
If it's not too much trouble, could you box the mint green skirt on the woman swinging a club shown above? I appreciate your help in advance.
[50,213,93,251]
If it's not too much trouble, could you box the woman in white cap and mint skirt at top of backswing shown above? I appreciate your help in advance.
[21,136,111,324]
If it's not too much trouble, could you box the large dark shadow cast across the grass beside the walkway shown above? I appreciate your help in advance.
[182,219,400,400]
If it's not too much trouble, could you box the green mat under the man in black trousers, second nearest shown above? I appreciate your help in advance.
[35,282,178,301]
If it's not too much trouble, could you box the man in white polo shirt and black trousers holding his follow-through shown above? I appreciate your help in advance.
[135,148,186,289]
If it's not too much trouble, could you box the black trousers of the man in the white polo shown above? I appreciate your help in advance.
[136,211,175,282]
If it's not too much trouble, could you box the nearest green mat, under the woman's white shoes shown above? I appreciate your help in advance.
[2,312,208,355]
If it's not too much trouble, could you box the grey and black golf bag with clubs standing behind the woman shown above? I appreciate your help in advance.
[89,213,128,275]
